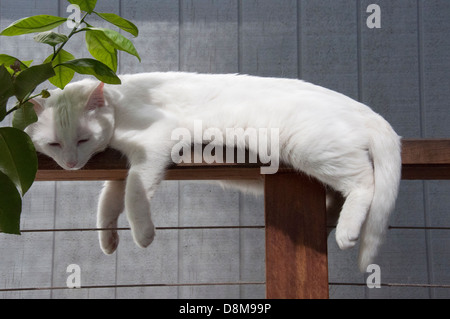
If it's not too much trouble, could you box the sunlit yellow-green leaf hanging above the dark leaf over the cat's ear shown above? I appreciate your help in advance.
[86,30,117,72]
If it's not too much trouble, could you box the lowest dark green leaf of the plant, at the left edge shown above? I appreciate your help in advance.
[0,172,22,235]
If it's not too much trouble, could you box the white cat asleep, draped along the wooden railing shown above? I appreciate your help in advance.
[26,72,401,271]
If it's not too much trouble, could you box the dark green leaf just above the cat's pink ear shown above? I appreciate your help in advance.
[57,59,121,84]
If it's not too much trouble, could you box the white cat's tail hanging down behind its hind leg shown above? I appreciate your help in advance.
[359,115,402,272]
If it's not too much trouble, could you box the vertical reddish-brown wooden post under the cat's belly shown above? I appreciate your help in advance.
[264,173,328,299]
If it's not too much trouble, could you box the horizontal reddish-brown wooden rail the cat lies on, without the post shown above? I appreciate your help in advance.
[36,139,450,181]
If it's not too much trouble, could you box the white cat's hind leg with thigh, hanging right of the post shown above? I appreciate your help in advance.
[284,138,375,249]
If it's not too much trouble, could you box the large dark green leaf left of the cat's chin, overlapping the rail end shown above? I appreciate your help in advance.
[0,127,38,195]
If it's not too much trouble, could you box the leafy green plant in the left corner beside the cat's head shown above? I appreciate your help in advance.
[0,0,140,234]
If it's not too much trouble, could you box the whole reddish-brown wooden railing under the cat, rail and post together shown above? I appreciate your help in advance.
[36,139,450,298]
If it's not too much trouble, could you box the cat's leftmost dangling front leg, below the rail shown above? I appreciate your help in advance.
[97,181,125,255]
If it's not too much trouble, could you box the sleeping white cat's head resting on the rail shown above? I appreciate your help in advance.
[25,80,114,170]
